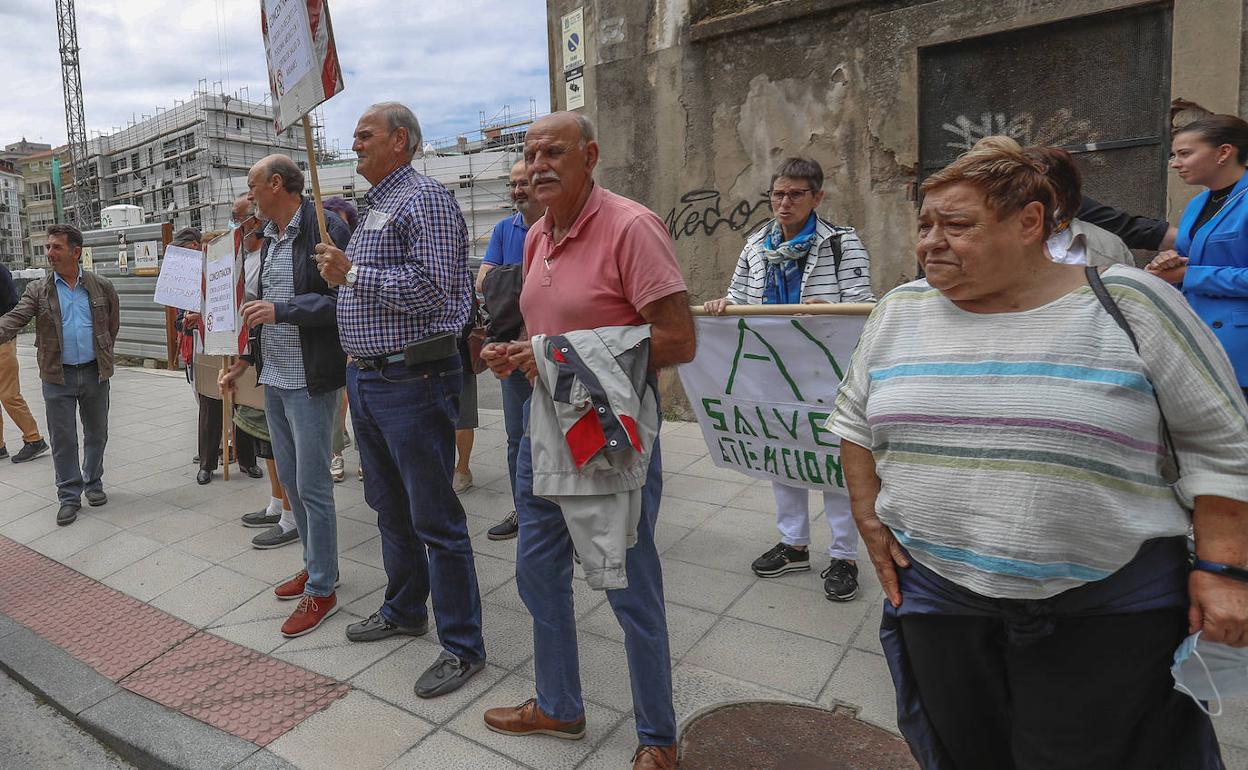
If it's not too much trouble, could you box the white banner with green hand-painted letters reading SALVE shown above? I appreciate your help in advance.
[679,316,866,492]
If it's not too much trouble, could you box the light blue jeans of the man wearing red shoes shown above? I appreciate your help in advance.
[265,386,342,597]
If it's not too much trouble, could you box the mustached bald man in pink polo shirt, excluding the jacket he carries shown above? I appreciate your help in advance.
[482,112,695,770]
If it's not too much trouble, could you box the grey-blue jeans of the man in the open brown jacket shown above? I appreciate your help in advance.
[44,362,109,505]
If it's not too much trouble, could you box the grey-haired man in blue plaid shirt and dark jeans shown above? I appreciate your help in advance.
[317,102,485,698]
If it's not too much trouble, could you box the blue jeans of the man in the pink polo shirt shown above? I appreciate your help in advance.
[515,404,676,746]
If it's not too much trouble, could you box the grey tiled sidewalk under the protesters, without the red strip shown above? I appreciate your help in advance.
[0,337,1248,770]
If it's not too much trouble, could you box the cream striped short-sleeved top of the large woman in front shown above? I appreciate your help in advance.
[829,266,1248,599]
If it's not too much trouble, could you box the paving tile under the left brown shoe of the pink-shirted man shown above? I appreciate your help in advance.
[448,675,623,770]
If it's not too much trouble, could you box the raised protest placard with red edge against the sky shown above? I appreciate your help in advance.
[260,0,342,132]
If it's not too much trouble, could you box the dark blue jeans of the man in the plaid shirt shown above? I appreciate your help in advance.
[347,356,485,663]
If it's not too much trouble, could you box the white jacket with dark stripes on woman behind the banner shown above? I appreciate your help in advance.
[728,220,875,305]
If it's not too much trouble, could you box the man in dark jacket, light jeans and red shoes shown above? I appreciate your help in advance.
[221,155,349,636]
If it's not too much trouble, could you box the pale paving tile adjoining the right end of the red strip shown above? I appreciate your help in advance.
[268,690,433,770]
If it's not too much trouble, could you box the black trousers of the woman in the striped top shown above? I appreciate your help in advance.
[901,609,1209,770]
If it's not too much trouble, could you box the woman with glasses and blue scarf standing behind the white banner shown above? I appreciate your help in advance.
[703,157,875,602]
